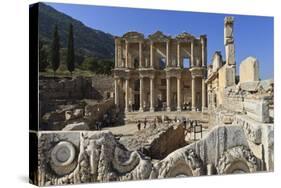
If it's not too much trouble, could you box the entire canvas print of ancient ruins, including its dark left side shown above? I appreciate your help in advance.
[29,3,274,186]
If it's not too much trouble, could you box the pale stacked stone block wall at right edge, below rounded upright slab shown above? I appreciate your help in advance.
[222,80,274,123]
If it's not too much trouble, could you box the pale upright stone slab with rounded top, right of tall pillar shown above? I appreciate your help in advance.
[240,56,260,83]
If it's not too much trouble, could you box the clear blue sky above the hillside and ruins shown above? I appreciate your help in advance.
[47,3,274,79]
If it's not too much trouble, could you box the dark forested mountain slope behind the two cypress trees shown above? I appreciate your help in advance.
[39,3,114,58]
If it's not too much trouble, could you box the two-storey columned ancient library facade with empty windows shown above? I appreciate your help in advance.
[114,31,207,112]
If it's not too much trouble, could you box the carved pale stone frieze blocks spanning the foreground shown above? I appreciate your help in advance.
[35,118,273,186]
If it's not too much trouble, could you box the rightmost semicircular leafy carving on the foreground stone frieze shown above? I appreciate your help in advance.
[217,146,260,174]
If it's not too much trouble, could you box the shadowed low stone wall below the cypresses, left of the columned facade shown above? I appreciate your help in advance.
[39,75,114,100]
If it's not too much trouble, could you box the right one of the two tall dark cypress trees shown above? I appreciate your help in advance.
[66,24,75,76]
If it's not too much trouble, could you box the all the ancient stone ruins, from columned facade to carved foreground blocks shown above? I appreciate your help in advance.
[34,17,274,186]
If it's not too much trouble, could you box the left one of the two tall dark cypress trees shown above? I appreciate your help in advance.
[51,25,60,77]
